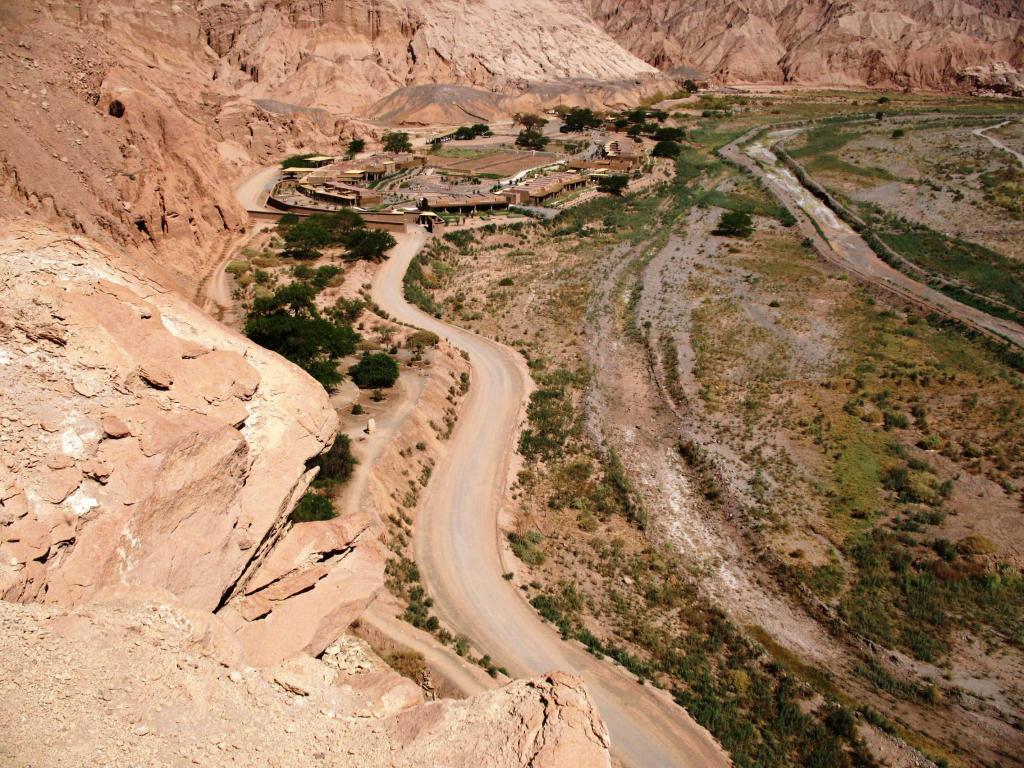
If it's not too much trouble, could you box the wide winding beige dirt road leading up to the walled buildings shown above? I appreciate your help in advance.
[372,232,730,768]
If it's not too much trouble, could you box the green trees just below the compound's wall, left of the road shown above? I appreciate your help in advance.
[278,210,395,261]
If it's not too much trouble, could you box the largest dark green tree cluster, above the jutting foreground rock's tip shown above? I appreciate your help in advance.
[245,280,359,389]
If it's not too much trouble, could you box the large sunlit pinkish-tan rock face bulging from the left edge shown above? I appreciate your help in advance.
[0,222,337,614]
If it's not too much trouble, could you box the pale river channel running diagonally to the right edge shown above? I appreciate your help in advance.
[722,130,1024,348]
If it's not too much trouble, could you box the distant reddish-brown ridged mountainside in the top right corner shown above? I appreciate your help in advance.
[586,0,1024,89]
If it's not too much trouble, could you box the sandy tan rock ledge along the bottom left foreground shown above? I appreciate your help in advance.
[0,599,610,768]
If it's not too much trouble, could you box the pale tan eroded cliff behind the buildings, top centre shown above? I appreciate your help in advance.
[200,0,654,111]
